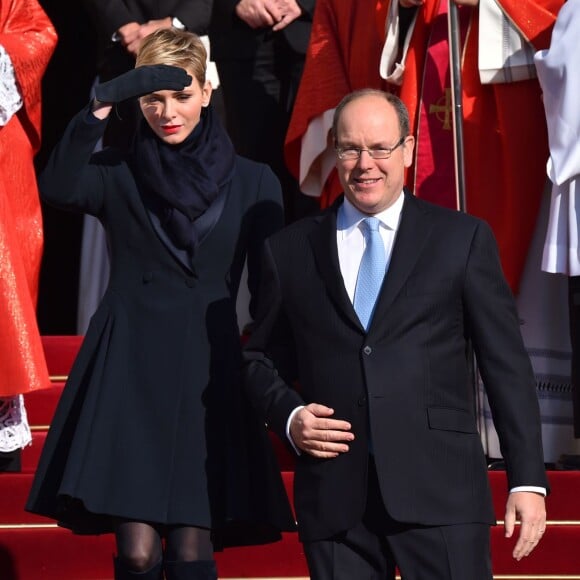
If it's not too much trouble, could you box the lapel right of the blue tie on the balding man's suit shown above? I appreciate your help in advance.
[370,192,433,329]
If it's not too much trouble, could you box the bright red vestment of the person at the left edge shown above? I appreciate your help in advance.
[0,0,57,396]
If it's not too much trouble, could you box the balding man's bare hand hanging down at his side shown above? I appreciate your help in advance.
[504,491,546,561]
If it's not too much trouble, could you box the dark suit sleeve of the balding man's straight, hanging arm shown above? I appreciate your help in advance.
[464,222,548,489]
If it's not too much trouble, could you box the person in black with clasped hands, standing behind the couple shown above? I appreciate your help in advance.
[210,0,318,221]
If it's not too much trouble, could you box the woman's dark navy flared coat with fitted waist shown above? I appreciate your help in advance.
[27,109,294,545]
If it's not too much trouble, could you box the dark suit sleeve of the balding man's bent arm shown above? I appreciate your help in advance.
[244,241,304,441]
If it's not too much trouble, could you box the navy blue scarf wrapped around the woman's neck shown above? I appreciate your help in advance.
[131,105,235,253]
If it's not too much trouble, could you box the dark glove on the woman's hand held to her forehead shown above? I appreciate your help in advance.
[95,64,192,103]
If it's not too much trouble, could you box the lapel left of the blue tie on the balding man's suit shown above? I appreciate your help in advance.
[310,196,362,329]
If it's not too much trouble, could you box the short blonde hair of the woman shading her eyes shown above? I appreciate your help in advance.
[135,28,207,87]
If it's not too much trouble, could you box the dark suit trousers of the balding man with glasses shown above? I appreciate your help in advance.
[304,457,493,580]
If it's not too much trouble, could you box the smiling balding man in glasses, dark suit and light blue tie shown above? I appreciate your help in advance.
[245,89,548,580]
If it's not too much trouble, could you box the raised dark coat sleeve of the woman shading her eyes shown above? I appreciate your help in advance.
[39,105,107,216]
